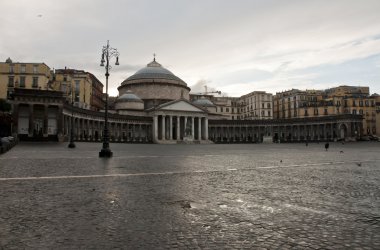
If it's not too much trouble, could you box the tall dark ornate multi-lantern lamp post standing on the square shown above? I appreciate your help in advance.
[99,40,119,158]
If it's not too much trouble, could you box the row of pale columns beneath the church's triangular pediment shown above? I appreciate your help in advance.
[153,114,208,143]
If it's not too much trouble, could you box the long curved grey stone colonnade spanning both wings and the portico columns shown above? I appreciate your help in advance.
[13,100,363,143]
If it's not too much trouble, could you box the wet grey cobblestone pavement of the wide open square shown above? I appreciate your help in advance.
[0,142,380,249]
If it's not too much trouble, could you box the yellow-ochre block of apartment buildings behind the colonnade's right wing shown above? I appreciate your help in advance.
[273,86,380,136]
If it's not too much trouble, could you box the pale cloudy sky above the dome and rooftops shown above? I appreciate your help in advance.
[0,0,380,96]
